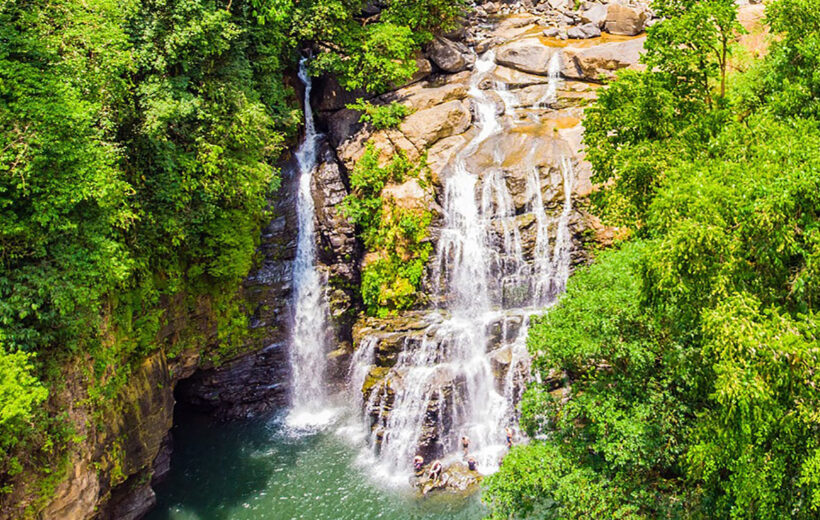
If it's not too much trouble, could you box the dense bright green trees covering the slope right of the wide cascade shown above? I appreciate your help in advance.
[485,0,820,519]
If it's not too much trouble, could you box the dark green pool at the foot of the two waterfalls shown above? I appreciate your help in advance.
[148,412,486,520]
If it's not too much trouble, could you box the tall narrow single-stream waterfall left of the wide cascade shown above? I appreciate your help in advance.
[288,58,328,428]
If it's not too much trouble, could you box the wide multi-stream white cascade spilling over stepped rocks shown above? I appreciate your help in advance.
[348,51,574,482]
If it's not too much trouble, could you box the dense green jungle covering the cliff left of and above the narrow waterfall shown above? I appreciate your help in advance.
[0,0,463,512]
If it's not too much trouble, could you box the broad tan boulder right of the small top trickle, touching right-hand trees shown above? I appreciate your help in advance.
[562,37,646,81]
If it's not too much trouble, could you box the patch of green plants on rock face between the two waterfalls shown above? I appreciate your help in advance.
[344,143,432,316]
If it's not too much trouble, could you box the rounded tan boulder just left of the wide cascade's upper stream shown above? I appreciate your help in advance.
[399,101,472,150]
